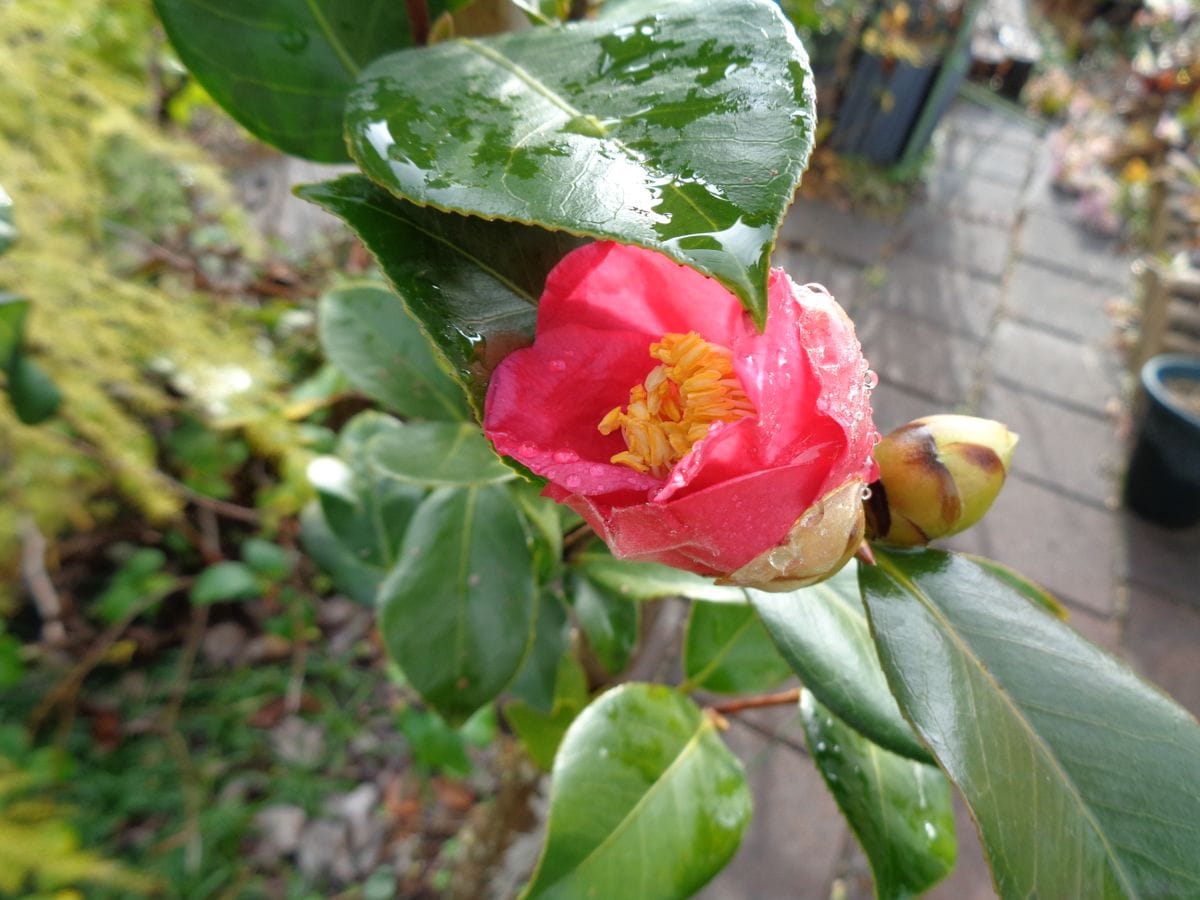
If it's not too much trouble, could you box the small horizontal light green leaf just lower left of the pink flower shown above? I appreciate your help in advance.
[367,422,516,487]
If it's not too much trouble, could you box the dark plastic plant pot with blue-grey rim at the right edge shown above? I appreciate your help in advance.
[1124,353,1200,528]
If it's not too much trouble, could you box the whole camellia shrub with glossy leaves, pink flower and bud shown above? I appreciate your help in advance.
[157,0,1200,898]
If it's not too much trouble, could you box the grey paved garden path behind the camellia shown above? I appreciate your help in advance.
[703,103,1200,900]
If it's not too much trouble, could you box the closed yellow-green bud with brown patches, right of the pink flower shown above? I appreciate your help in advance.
[866,415,1018,547]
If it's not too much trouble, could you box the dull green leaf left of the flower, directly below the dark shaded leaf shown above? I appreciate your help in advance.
[318,284,470,421]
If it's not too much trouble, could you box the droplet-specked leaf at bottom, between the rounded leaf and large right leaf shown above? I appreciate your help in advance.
[800,690,958,900]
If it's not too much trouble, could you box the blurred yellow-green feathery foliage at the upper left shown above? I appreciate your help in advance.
[0,0,314,592]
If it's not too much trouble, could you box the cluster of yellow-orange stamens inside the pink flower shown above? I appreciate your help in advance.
[596,331,755,478]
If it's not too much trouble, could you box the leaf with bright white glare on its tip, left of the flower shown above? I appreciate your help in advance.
[307,410,425,572]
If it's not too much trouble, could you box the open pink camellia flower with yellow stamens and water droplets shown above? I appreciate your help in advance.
[484,242,878,589]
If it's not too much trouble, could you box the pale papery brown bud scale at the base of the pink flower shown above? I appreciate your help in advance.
[718,479,865,592]
